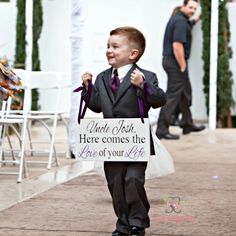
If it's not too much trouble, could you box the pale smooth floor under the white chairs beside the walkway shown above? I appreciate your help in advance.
[0,125,93,210]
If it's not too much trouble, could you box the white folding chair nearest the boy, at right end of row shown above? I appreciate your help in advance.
[22,71,69,169]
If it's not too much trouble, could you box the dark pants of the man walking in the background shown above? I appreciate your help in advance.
[156,57,193,136]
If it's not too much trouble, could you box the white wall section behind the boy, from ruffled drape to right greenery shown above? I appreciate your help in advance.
[71,0,206,120]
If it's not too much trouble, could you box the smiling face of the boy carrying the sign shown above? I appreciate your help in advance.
[106,35,137,68]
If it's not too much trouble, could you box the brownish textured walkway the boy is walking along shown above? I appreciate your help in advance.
[0,128,236,236]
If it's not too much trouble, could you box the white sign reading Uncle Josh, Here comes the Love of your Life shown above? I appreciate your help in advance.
[75,118,150,161]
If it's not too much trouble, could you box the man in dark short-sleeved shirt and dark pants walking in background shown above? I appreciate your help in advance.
[156,0,205,139]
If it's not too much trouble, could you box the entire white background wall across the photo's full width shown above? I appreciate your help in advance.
[0,0,236,120]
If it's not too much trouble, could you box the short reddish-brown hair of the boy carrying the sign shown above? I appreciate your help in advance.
[110,26,146,62]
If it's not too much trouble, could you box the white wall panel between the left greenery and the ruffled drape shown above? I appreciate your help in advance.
[39,0,71,111]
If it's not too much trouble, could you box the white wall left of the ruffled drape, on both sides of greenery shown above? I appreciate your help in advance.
[0,0,71,111]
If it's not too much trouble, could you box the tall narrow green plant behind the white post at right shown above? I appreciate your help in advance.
[200,0,234,127]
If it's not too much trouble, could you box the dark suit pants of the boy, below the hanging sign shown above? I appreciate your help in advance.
[104,162,150,233]
